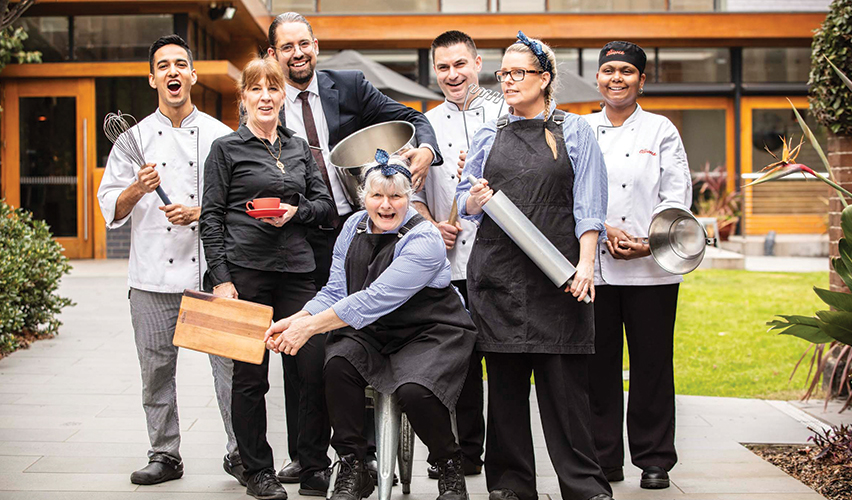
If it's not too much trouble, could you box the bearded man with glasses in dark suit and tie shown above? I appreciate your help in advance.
[268,12,443,495]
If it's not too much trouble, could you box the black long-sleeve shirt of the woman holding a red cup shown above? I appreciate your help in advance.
[199,125,334,286]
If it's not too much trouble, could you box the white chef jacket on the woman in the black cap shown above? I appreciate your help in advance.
[583,104,692,285]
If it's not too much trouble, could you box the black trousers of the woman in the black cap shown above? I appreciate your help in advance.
[589,284,679,470]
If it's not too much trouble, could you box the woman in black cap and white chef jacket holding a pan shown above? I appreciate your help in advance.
[583,42,692,489]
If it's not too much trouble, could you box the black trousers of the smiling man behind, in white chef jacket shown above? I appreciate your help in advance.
[453,280,485,465]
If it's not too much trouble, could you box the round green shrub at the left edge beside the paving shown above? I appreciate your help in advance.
[0,200,73,355]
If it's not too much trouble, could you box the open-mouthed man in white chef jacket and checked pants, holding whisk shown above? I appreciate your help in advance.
[98,35,245,485]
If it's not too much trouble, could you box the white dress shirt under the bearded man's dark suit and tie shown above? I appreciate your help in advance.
[284,75,352,215]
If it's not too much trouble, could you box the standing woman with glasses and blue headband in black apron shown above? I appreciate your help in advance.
[456,32,612,500]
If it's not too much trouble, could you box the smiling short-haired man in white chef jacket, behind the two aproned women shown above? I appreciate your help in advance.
[413,31,502,479]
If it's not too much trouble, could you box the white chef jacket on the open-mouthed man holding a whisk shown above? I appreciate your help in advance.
[98,108,231,293]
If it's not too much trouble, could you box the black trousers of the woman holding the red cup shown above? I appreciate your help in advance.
[228,264,331,477]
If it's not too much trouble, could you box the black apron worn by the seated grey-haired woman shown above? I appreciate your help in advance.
[326,214,476,410]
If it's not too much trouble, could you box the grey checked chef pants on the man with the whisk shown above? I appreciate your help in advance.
[129,289,240,463]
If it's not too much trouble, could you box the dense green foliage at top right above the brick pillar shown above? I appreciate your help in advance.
[808,0,852,135]
